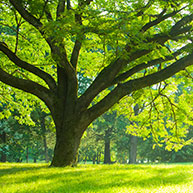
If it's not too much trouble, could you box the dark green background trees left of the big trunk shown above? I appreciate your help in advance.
[0,104,55,162]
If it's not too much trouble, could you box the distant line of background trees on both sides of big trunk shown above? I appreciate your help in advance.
[0,102,193,164]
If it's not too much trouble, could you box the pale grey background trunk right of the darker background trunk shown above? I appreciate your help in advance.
[129,135,137,164]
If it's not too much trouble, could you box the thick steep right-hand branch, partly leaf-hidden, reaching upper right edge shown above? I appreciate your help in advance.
[80,14,193,107]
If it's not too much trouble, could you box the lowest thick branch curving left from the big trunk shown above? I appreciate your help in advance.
[0,68,53,108]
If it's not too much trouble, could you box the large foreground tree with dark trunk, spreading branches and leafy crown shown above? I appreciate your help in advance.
[0,0,193,166]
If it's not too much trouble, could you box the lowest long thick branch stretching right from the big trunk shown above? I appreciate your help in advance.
[85,52,193,121]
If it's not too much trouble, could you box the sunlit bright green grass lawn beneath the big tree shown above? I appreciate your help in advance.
[0,163,193,193]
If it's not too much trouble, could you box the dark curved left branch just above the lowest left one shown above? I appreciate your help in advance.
[0,42,56,90]
